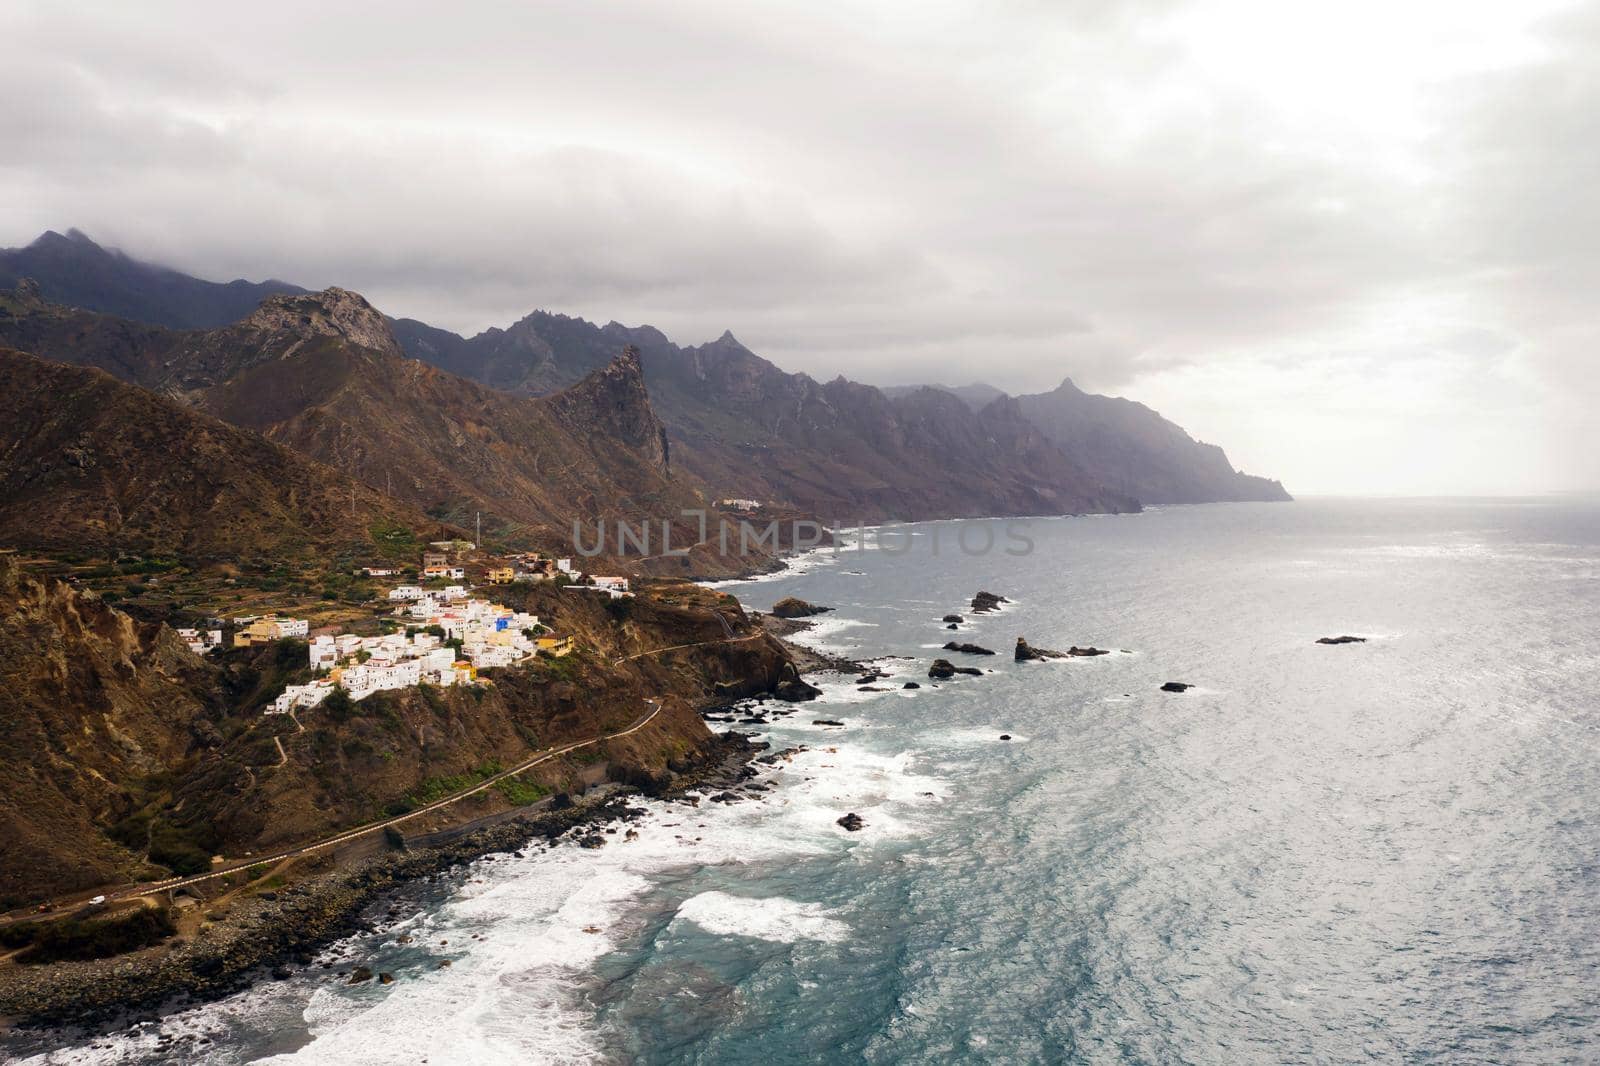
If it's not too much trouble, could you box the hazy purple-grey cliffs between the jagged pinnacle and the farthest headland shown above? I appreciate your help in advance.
[394,312,1139,522]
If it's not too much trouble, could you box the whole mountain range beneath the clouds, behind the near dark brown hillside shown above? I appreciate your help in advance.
[0,230,1288,563]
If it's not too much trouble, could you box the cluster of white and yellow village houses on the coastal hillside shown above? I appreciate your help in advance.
[178,541,634,714]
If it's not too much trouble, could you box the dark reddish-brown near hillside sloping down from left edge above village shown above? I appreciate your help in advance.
[0,349,437,559]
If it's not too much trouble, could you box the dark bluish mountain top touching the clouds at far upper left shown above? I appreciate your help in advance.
[0,229,306,330]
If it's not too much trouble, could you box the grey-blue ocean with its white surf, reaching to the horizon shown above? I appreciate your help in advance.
[12,498,1600,1066]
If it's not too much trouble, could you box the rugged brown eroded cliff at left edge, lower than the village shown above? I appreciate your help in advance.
[0,555,222,906]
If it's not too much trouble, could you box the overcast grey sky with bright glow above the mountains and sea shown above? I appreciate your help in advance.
[0,0,1600,493]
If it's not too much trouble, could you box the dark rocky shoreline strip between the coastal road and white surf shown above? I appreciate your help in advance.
[0,733,768,1032]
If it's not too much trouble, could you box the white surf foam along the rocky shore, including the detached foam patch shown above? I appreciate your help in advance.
[32,713,946,1066]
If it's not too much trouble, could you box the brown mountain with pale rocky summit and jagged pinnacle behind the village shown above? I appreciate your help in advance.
[0,281,748,563]
